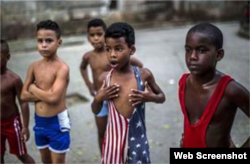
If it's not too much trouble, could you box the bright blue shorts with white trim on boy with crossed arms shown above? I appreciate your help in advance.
[33,110,71,153]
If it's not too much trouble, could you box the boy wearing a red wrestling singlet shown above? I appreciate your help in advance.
[179,23,250,147]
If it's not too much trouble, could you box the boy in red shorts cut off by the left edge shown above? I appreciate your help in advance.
[0,39,35,164]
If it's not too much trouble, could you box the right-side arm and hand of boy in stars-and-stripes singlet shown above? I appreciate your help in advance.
[129,68,165,106]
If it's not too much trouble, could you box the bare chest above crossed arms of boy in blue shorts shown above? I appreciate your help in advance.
[34,65,57,89]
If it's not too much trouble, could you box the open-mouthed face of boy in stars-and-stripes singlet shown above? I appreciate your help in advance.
[105,37,135,68]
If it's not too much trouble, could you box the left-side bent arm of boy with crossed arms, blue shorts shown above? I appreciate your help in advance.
[21,64,39,102]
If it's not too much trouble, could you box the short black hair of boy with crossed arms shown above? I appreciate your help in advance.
[36,20,61,39]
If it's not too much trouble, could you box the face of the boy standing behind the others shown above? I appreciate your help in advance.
[88,26,105,49]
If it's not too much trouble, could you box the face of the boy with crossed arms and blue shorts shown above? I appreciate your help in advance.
[37,29,62,57]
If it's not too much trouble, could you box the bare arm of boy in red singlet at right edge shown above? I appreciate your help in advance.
[227,81,250,148]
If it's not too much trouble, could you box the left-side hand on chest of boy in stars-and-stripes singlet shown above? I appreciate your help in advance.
[95,80,120,102]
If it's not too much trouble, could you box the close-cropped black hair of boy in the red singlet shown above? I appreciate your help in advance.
[187,23,223,49]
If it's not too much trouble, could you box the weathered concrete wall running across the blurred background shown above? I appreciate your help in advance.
[0,0,246,40]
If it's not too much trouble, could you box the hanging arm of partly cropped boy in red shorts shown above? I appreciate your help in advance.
[15,77,30,141]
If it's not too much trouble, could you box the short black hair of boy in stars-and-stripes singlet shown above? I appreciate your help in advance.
[105,22,135,47]
